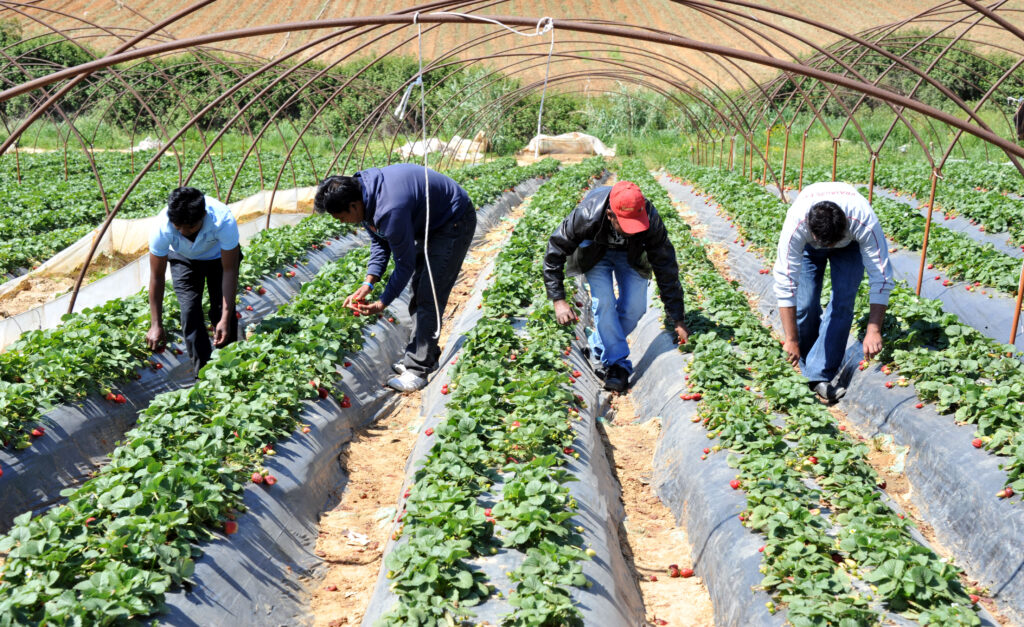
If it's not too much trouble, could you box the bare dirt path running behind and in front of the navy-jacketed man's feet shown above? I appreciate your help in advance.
[311,205,525,627]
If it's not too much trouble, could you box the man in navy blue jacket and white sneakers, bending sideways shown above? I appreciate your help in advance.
[313,163,476,391]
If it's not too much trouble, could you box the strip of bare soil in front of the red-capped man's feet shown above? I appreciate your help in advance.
[602,394,715,627]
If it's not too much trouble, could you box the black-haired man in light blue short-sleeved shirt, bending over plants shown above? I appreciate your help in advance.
[145,187,242,374]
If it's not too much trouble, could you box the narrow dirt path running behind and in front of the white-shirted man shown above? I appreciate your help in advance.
[673,181,1012,627]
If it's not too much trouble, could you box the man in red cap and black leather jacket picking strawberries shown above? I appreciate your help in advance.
[544,180,689,392]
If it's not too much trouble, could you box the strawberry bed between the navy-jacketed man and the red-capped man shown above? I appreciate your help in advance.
[364,160,643,625]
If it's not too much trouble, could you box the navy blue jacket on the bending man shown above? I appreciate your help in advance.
[355,163,472,306]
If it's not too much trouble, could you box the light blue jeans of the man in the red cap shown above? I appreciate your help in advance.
[587,250,647,374]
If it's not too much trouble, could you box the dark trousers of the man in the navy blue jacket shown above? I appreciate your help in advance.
[403,206,476,377]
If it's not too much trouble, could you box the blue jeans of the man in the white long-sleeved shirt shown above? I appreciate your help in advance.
[797,242,864,381]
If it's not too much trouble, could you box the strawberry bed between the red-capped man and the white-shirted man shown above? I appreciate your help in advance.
[620,162,979,625]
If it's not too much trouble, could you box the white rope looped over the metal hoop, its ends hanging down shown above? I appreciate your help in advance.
[409,11,555,339]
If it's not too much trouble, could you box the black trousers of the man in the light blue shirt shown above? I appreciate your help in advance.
[167,252,239,374]
